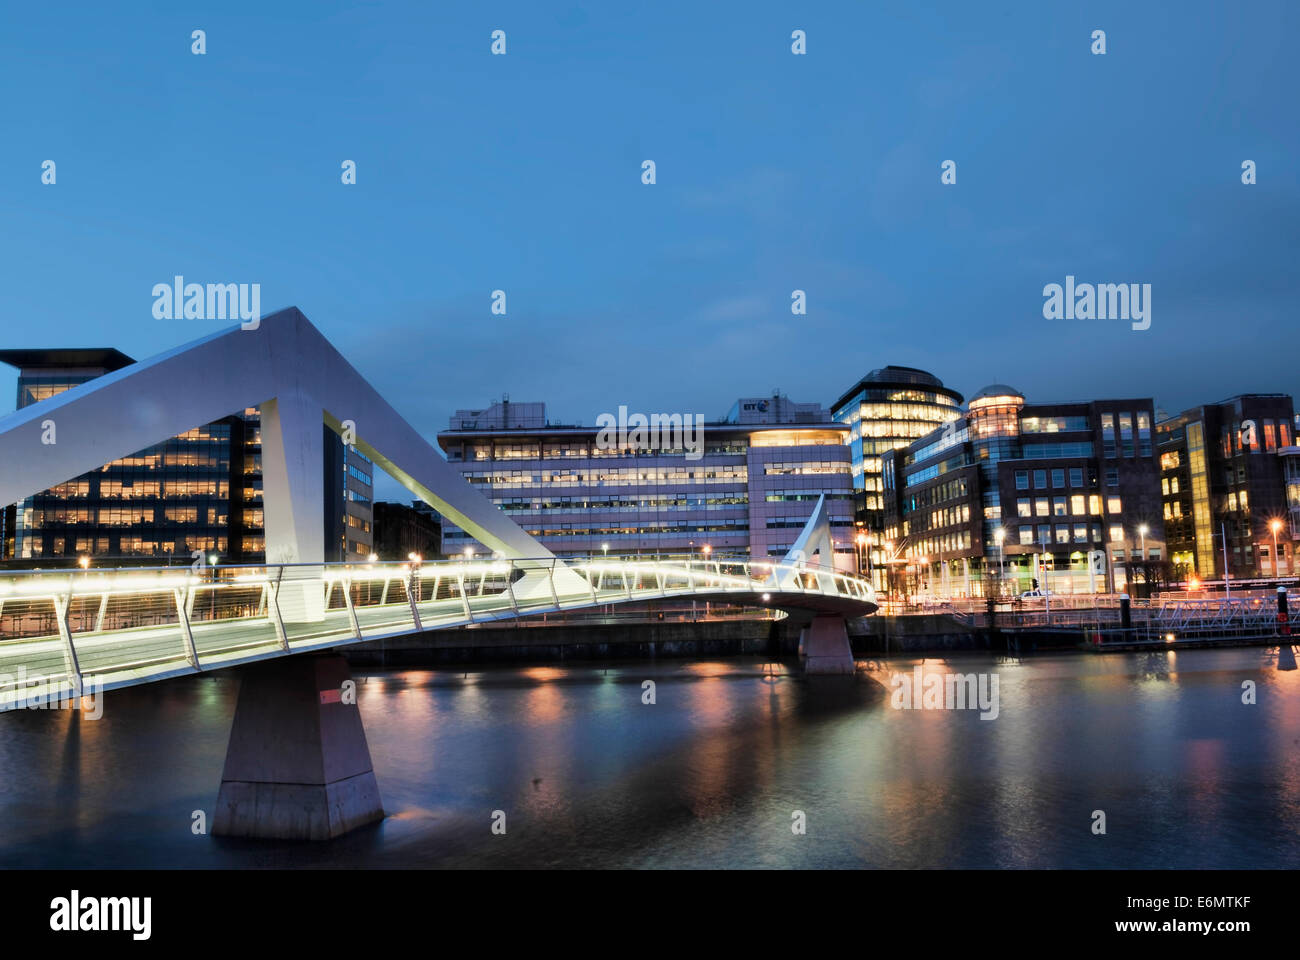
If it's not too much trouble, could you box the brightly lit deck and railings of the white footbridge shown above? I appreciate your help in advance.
[0,557,875,708]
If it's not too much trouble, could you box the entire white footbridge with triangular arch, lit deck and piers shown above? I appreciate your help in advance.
[0,307,876,839]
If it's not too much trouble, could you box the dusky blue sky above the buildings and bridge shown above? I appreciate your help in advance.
[0,0,1300,502]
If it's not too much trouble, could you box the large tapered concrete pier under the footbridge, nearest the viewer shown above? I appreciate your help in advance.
[212,654,384,840]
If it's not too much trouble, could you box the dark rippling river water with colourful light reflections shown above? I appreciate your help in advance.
[0,648,1300,868]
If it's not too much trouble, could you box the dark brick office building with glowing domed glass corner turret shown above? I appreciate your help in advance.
[883,384,1165,596]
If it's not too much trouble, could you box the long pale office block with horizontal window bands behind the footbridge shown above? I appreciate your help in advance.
[438,394,857,570]
